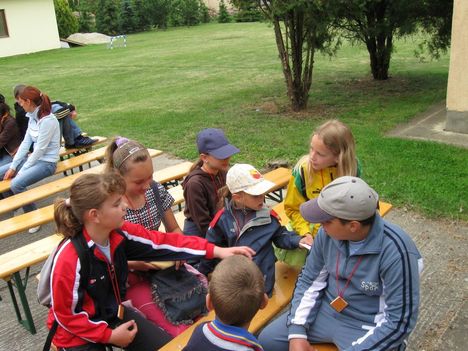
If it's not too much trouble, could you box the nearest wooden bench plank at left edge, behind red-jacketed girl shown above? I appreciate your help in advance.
[0,234,62,280]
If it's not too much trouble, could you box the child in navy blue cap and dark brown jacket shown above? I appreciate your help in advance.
[182,128,239,238]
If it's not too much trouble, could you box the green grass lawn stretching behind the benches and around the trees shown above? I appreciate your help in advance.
[0,23,468,220]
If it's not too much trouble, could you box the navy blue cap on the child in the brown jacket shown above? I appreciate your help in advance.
[197,128,239,160]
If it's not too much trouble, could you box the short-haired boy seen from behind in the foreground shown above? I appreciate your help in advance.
[183,256,268,351]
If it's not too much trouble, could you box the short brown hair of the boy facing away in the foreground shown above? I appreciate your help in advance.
[209,255,265,327]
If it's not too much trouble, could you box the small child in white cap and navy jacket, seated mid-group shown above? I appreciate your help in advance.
[198,164,312,296]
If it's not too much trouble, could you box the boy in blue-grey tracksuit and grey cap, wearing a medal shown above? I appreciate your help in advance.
[259,176,422,351]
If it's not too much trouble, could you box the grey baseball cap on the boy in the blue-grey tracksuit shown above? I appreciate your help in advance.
[300,176,379,223]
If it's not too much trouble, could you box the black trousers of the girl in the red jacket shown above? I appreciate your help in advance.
[59,307,172,351]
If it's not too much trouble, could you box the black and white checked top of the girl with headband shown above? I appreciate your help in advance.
[125,183,174,230]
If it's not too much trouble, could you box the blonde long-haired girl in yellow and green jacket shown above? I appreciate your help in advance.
[275,119,361,267]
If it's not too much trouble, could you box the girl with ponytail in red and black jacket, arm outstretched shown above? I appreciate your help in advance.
[47,174,254,351]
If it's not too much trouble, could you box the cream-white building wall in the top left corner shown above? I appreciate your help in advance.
[0,0,60,57]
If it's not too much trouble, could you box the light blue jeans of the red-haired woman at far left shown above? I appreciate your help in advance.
[0,158,57,213]
